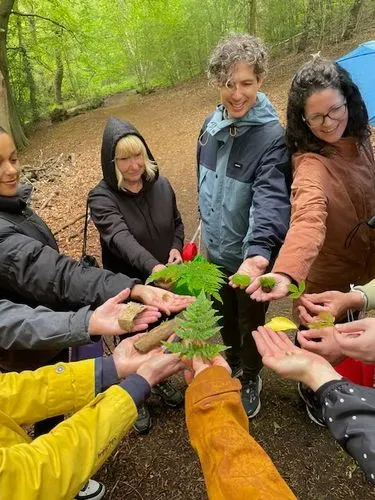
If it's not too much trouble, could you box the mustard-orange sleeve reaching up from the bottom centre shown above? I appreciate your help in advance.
[185,367,296,500]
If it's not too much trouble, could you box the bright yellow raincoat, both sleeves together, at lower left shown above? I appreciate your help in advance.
[0,360,137,500]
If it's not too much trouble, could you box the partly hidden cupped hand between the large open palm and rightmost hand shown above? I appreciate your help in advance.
[297,326,346,365]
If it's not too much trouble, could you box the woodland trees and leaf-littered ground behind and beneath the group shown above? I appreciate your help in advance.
[0,0,375,500]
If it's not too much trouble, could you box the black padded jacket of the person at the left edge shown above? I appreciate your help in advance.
[0,185,135,370]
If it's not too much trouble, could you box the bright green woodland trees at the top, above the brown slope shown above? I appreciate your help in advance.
[0,0,375,148]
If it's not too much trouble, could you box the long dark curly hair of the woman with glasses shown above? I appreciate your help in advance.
[286,57,370,156]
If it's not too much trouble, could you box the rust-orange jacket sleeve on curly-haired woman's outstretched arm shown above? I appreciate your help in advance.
[272,158,329,282]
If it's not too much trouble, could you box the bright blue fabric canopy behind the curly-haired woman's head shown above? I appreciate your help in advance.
[337,40,375,125]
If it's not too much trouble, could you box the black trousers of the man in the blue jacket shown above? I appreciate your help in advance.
[214,282,268,383]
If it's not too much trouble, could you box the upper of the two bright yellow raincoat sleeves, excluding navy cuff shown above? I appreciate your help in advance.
[0,359,95,425]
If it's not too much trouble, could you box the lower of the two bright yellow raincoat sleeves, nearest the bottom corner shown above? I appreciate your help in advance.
[0,386,137,500]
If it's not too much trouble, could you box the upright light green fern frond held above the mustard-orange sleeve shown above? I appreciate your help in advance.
[163,292,227,359]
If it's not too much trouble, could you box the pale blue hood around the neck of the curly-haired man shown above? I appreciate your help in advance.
[205,92,279,141]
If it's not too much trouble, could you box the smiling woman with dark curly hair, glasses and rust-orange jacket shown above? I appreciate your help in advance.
[247,58,375,421]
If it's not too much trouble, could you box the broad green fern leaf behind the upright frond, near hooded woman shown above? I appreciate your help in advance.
[146,256,225,302]
